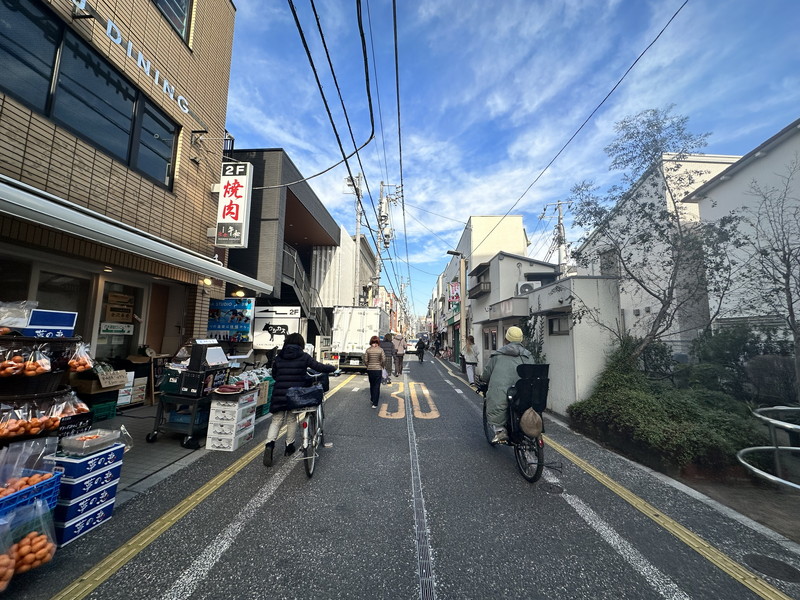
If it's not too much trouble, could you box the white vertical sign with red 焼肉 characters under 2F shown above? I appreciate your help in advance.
[214,163,253,248]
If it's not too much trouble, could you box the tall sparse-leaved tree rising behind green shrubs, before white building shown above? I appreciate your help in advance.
[572,107,737,358]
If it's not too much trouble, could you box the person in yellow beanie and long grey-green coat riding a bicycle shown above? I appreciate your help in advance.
[481,327,533,443]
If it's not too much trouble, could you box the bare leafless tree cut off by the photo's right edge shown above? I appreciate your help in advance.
[743,155,800,404]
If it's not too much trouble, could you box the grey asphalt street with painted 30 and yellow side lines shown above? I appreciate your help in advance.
[6,359,800,600]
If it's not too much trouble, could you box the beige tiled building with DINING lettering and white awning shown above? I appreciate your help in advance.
[0,0,272,358]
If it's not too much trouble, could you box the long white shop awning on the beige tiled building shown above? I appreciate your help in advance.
[0,175,272,295]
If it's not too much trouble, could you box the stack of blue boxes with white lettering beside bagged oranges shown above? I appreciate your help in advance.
[53,444,125,547]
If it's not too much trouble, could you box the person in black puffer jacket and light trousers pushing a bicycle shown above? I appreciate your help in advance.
[264,333,336,467]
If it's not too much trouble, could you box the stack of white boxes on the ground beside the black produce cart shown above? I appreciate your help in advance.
[206,388,258,452]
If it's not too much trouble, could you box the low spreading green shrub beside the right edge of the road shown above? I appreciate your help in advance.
[567,346,768,472]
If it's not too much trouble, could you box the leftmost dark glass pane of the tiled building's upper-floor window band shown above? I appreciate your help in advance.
[0,0,61,112]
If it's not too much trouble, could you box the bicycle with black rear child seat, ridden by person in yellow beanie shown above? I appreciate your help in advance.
[475,364,549,483]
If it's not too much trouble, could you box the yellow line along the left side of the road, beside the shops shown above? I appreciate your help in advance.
[52,375,355,600]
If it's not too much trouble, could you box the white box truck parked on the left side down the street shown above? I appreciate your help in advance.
[322,306,389,371]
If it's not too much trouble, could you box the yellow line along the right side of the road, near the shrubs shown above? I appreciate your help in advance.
[545,436,792,600]
